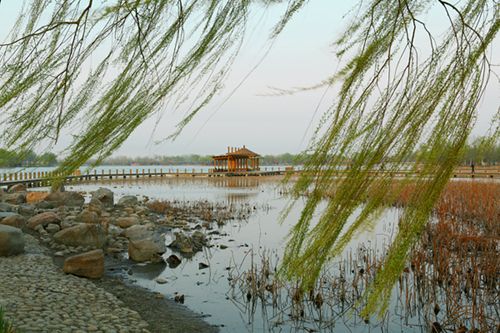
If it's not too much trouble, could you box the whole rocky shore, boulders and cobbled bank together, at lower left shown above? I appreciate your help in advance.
[0,184,218,333]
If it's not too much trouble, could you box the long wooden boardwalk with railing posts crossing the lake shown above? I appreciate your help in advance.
[0,166,500,187]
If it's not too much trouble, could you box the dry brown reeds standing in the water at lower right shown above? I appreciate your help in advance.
[228,181,500,332]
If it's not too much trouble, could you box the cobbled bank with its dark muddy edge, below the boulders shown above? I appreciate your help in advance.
[0,232,219,333]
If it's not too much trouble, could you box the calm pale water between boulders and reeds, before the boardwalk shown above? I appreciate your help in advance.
[50,172,420,332]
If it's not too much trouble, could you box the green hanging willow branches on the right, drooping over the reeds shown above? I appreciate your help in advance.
[280,0,500,316]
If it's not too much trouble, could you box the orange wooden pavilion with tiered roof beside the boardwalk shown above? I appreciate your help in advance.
[212,146,260,172]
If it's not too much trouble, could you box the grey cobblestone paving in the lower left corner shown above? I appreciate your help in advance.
[0,234,149,333]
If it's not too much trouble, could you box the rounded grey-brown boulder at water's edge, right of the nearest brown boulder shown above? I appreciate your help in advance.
[128,231,167,261]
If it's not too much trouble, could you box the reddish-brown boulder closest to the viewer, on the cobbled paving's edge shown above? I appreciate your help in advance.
[63,250,104,279]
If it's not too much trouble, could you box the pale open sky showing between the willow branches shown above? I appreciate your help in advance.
[0,0,500,157]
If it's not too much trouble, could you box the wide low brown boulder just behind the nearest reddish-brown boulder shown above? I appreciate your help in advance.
[54,223,107,248]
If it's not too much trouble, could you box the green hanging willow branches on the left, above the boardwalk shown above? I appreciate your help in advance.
[0,0,303,175]
